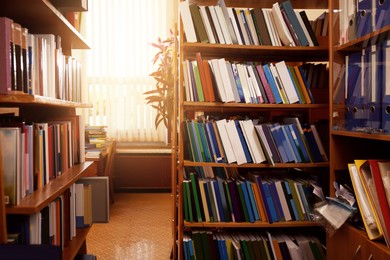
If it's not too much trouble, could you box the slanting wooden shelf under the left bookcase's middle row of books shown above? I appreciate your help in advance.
[6,162,93,215]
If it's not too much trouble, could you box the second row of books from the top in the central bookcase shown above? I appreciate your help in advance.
[183,52,327,104]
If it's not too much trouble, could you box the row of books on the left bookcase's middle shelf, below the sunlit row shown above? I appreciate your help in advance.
[0,116,84,206]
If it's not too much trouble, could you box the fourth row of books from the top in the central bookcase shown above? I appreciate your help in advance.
[183,171,324,223]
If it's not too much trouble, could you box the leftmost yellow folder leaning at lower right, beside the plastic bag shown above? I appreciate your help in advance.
[348,162,383,240]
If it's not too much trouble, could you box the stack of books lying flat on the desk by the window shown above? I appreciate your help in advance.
[85,126,107,158]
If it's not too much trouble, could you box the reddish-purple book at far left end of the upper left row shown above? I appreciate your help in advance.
[0,17,12,94]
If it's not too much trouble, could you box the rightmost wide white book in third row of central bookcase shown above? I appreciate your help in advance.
[239,120,267,163]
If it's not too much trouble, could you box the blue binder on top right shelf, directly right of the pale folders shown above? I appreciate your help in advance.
[356,0,373,37]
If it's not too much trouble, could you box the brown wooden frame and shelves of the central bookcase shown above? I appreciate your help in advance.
[174,0,330,259]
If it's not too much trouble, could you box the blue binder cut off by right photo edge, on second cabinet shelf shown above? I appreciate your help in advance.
[381,40,390,133]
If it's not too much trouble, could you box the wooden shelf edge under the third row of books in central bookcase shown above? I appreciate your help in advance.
[183,161,329,168]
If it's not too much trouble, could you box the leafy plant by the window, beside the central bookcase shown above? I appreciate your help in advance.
[143,31,176,133]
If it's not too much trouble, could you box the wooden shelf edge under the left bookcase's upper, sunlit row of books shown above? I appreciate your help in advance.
[0,93,92,108]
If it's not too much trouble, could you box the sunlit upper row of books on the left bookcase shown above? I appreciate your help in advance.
[0,17,81,102]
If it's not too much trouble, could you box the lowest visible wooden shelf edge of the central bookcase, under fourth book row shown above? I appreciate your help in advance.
[184,221,320,228]
